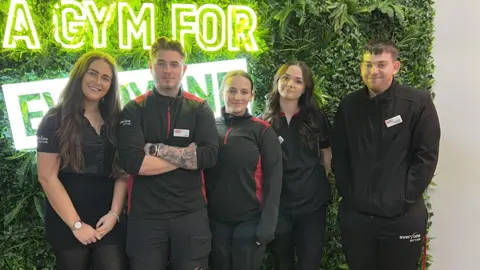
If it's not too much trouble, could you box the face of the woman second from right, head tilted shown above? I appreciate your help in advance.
[277,65,305,100]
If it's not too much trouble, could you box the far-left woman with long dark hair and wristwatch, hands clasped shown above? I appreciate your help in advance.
[37,52,127,270]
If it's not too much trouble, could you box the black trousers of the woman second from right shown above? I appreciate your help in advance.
[271,204,327,270]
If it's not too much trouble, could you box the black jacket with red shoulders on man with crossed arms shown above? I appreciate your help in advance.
[117,89,218,218]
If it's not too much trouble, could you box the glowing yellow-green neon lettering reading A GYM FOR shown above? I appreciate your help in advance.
[3,0,258,51]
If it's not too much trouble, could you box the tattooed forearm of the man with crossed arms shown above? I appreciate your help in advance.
[157,144,198,170]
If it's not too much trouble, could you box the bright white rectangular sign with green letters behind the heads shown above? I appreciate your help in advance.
[2,59,251,150]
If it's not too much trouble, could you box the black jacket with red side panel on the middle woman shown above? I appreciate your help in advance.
[205,109,282,244]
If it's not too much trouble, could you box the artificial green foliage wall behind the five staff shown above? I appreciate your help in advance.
[0,0,434,270]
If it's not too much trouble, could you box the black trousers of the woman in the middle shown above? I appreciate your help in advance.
[210,218,266,270]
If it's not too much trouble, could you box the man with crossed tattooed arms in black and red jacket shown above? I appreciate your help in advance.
[117,38,218,270]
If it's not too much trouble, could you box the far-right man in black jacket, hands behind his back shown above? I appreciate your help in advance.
[331,41,440,270]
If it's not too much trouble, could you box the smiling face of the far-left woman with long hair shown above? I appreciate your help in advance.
[82,59,113,102]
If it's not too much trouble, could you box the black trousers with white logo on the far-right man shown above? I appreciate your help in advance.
[338,201,428,270]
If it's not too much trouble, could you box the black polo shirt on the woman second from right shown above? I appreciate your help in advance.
[277,112,331,214]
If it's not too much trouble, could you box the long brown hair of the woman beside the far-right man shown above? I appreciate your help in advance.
[263,61,324,149]
